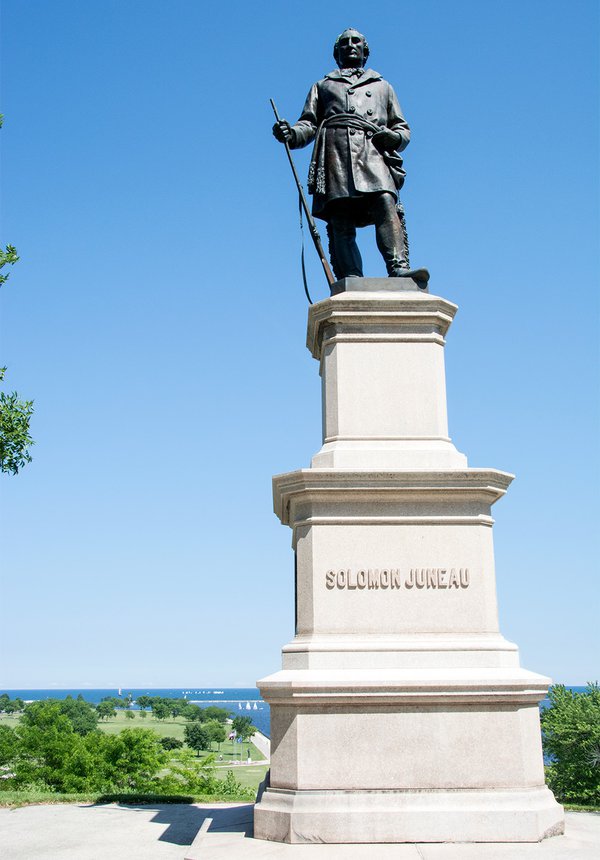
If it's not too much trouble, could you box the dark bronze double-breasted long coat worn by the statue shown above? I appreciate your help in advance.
[291,69,410,220]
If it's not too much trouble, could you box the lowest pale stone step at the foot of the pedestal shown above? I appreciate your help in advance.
[254,787,564,843]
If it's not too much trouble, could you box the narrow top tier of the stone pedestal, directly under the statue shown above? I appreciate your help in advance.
[307,292,467,469]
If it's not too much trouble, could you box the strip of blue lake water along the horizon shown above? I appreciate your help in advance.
[0,687,585,737]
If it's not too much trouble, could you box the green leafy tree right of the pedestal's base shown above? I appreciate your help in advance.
[541,684,600,805]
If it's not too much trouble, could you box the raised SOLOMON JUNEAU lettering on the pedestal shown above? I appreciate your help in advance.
[325,567,471,591]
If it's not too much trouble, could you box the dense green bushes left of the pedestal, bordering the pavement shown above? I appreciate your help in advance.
[0,697,253,799]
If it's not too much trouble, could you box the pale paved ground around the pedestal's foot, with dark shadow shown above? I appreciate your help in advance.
[0,804,600,860]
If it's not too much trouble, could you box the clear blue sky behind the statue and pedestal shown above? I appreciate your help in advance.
[0,0,600,687]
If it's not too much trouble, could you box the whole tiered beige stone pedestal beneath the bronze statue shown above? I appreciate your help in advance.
[255,286,563,843]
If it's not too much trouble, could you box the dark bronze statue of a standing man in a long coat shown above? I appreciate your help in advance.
[273,29,422,284]
